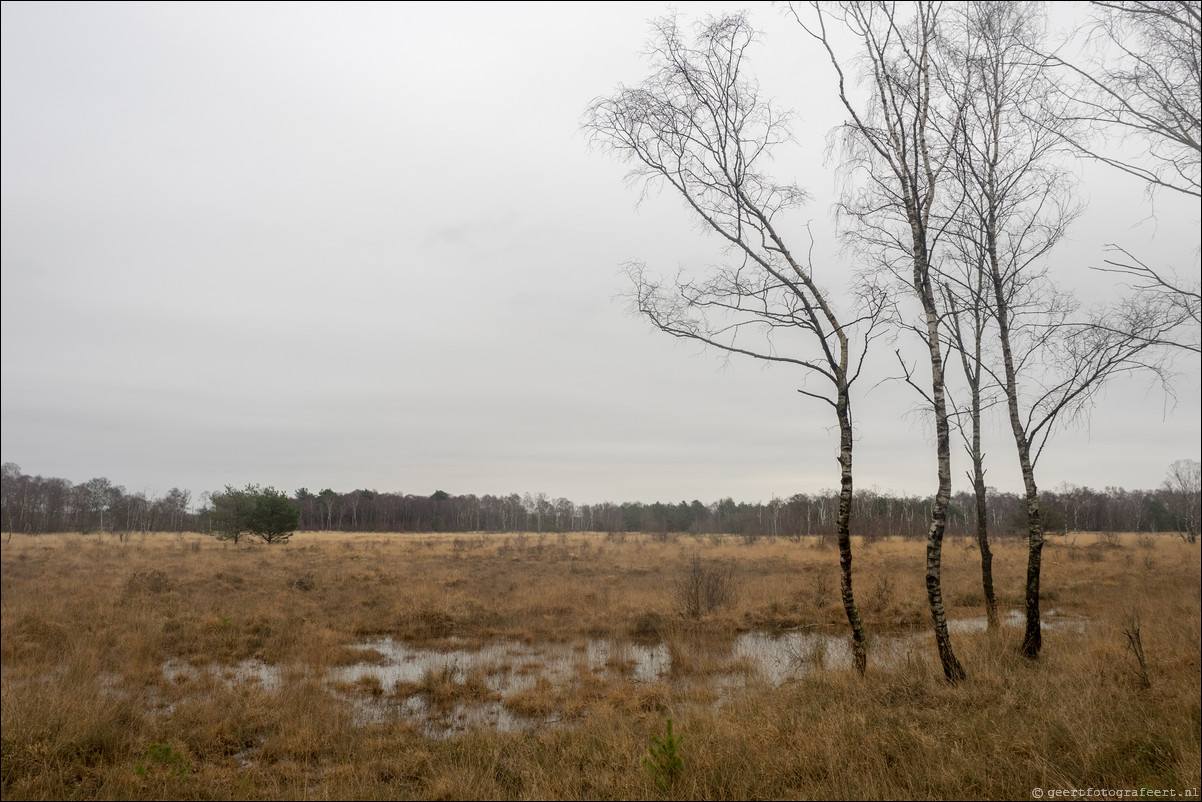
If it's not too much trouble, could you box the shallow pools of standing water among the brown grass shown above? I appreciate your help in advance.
[145,610,1088,738]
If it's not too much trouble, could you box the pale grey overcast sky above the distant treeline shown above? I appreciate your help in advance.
[0,2,1200,503]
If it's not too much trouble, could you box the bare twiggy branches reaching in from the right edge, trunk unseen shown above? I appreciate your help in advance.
[1045,0,1202,354]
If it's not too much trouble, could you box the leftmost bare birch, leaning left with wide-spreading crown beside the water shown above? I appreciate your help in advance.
[585,14,883,673]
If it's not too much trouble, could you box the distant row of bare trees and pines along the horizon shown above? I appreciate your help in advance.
[0,463,1197,537]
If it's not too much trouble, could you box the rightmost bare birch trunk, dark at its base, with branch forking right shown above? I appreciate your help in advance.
[942,2,1156,659]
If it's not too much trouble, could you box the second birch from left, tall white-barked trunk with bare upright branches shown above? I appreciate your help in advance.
[792,1,965,682]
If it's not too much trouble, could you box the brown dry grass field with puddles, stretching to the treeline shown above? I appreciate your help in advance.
[0,533,1202,800]
